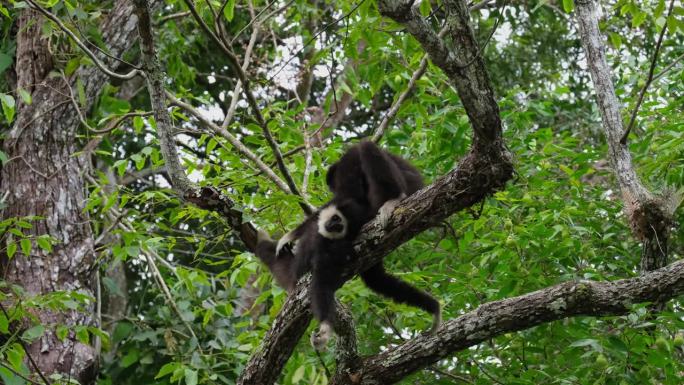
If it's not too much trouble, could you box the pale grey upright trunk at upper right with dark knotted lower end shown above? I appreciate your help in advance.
[576,0,680,271]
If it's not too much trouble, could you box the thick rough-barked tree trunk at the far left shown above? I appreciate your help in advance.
[0,1,146,384]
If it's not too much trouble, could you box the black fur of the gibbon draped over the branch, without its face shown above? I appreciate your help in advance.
[256,141,440,348]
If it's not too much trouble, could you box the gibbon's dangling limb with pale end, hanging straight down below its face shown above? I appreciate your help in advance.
[311,270,335,351]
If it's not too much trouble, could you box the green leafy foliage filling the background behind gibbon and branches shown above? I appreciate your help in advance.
[0,0,684,385]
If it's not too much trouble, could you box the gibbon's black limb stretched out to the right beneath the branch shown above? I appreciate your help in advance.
[360,262,442,333]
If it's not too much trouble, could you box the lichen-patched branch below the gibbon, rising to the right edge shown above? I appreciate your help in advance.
[350,260,684,385]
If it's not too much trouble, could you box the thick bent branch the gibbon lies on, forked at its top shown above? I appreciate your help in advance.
[238,0,513,385]
